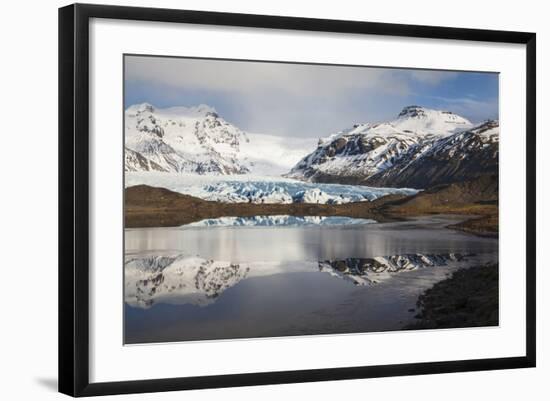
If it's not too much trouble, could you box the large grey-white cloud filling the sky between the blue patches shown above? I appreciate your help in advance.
[125,56,488,136]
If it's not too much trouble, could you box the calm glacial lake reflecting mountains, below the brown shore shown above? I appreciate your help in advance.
[124,216,498,344]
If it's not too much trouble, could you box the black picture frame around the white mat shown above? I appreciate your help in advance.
[59,4,536,396]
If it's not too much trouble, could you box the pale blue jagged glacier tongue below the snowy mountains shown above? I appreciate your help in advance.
[125,171,418,204]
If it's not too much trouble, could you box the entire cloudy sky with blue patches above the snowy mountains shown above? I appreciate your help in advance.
[124,56,498,137]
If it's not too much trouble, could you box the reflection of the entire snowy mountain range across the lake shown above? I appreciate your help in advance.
[124,253,474,308]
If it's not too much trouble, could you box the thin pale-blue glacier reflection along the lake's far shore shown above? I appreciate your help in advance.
[188,215,376,228]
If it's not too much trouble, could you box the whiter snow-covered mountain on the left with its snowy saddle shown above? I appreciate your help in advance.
[125,103,314,175]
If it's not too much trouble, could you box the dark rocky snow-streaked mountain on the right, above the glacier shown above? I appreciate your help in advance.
[287,106,499,188]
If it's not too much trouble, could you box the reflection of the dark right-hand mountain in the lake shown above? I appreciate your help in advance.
[319,253,473,285]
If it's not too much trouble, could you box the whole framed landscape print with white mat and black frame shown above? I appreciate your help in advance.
[59,4,536,396]
